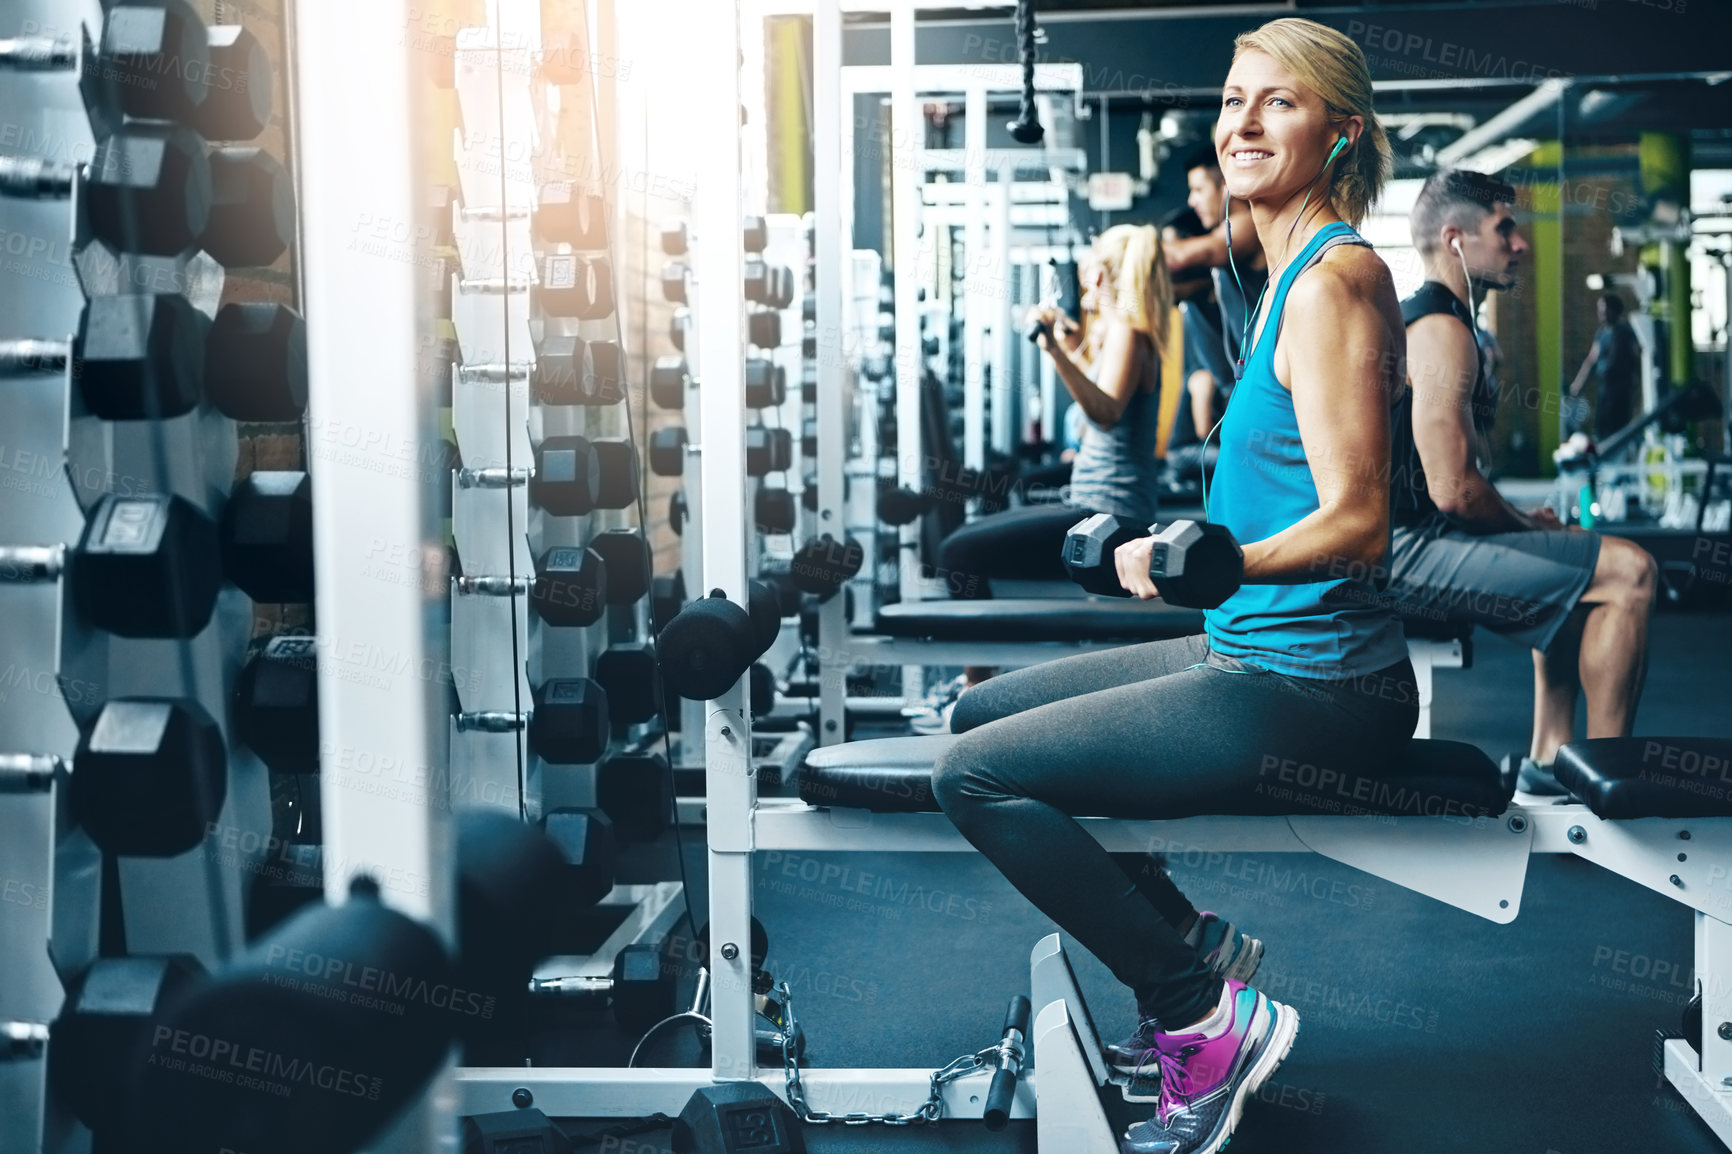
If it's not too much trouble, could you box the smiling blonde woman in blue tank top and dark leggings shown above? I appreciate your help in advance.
[934,19,1419,1154]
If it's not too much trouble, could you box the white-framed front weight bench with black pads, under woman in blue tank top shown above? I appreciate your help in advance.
[772,735,1732,1154]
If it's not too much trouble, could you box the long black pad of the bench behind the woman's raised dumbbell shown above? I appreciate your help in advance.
[876,598,1202,641]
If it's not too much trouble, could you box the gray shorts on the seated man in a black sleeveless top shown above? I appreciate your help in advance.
[1386,520,1600,652]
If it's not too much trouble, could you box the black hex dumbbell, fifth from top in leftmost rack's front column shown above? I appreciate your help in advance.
[71,697,229,858]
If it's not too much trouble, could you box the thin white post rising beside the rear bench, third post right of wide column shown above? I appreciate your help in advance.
[889,0,925,609]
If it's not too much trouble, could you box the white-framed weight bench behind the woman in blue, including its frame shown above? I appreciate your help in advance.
[849,598,1474,738]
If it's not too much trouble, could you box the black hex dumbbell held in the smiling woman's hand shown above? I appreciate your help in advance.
[1063,513,1245,608]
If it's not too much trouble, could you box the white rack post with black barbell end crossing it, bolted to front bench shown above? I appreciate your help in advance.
[688,0,762,1081]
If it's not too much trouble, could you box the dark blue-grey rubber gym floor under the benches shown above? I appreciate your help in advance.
[557,613,1732,1154]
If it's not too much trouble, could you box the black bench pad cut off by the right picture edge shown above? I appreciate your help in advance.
[1554,738,1732,818]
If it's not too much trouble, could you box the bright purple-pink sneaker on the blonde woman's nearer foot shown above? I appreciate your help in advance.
[1119,981,1299,1154]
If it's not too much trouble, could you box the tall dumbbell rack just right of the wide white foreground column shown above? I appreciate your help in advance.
[422,10,706,1066]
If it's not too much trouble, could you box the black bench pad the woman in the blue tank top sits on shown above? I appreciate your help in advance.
[798,735,1514,818]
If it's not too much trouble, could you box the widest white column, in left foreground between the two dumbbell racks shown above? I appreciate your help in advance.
[294,0,454,1154]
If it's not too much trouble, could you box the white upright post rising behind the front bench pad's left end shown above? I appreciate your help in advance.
[812,0,848,745]
